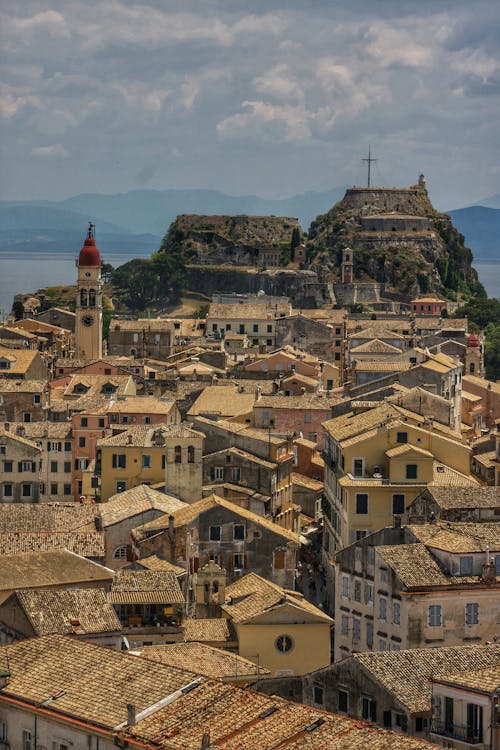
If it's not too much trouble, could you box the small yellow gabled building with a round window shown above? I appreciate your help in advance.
[222,573,333,677]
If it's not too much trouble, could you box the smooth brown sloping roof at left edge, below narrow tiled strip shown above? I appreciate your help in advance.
[0,550,113,591]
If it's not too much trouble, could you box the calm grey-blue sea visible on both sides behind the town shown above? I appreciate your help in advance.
[0,251,500,320]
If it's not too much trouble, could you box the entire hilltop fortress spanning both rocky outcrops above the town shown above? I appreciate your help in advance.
[162,175,478,309]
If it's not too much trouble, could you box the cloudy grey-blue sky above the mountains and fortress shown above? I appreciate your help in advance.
[0,0,500,210]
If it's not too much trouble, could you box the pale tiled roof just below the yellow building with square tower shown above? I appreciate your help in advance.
[98,484,186,528]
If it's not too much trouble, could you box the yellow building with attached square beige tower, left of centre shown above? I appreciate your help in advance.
[94,424,205,502]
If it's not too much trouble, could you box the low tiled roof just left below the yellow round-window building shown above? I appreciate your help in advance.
[135,641,269,679]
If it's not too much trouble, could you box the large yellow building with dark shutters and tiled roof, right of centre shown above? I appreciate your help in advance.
[323,403,478,558]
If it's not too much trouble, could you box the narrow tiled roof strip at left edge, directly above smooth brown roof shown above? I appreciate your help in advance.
[0,531,105,558]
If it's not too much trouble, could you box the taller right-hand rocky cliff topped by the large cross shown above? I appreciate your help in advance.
[308,176,481,297]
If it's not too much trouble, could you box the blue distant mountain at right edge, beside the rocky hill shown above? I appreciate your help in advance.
[447,206,500,260]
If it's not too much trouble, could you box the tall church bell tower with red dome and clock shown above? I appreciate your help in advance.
[75,224,102,360]
